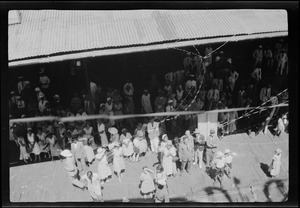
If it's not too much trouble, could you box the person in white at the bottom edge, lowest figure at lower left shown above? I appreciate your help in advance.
[81,171,103,202]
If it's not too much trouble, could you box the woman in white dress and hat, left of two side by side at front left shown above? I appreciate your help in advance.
[95,146,112,184]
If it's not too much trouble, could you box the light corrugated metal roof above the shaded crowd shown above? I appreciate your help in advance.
[8,10,288,61]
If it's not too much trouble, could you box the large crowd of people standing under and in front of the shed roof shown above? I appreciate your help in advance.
[9,40,288,202]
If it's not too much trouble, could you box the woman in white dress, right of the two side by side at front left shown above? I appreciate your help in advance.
[112,143,125,183]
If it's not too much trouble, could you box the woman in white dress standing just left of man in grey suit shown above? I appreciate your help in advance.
[162,140,177,176]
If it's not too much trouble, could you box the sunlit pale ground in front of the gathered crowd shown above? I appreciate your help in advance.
[10,133,289,203]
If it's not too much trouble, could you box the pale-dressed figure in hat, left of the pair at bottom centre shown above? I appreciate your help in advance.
[140,166,155,199]
